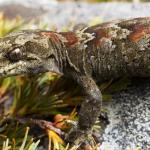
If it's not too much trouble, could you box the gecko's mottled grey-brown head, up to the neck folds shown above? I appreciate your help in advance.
[0,30,58,77]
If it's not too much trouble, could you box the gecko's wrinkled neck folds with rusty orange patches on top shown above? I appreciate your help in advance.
[41,31,78,72]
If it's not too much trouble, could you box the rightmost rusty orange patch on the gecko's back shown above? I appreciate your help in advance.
[129,25,150,42]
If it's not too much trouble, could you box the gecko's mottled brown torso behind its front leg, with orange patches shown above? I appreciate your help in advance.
[82,18,150,81]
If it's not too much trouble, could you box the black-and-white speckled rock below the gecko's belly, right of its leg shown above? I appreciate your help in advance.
[100,79,150,150]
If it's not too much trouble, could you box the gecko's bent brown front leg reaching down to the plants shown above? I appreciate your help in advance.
[66,76,102,143]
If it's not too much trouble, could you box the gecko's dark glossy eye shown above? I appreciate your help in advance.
[6,47,26,62]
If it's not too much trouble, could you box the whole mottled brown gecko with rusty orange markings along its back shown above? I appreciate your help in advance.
[0,18,150,143]
